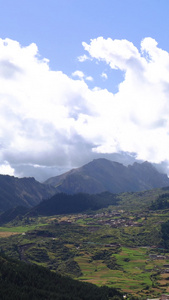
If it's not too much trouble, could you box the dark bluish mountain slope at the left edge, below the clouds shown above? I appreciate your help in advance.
[0,175,55,212]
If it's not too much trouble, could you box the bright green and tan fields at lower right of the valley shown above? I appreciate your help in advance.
[76,247,166,296]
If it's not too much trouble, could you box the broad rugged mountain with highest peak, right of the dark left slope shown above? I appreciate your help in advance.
[44,158,169,194]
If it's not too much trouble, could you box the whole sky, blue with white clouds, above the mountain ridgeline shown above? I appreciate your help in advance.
[0,0,169,181]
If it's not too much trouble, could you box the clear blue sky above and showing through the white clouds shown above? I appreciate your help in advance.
[0,0,169,91]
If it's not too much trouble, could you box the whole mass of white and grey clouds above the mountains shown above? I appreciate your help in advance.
[0,37,169,180]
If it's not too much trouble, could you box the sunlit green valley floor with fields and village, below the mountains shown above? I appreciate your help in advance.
[0,188,169,298]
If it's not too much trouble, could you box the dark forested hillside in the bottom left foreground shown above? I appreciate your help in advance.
[0,256,123,300]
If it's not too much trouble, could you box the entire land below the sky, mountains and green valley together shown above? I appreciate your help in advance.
[0,159,169,300]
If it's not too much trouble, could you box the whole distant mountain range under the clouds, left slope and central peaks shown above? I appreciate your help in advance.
[0,158,169,212]
